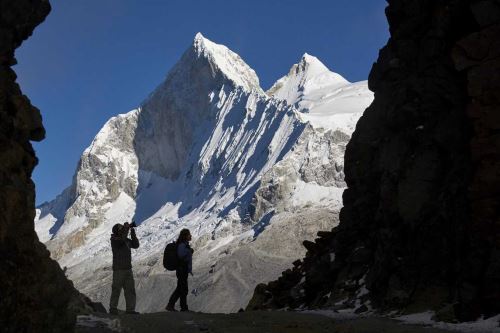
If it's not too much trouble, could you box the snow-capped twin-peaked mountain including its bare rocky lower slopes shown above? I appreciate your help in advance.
[35,34,373,312]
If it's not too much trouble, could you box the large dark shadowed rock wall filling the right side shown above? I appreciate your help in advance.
[249,0,500,320]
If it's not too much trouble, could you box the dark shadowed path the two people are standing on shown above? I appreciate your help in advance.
[76,311,458,333]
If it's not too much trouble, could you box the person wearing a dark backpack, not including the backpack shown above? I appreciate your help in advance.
[165,229,193,311]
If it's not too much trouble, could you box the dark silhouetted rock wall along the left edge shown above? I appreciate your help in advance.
[0,0,83,332]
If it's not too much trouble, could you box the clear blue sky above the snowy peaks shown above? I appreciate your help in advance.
[14,0,388,204]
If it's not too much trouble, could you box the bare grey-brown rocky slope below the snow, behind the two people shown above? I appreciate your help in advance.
[68,207,338,313]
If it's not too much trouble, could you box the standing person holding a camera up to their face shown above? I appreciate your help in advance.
[109,222,139,314]
